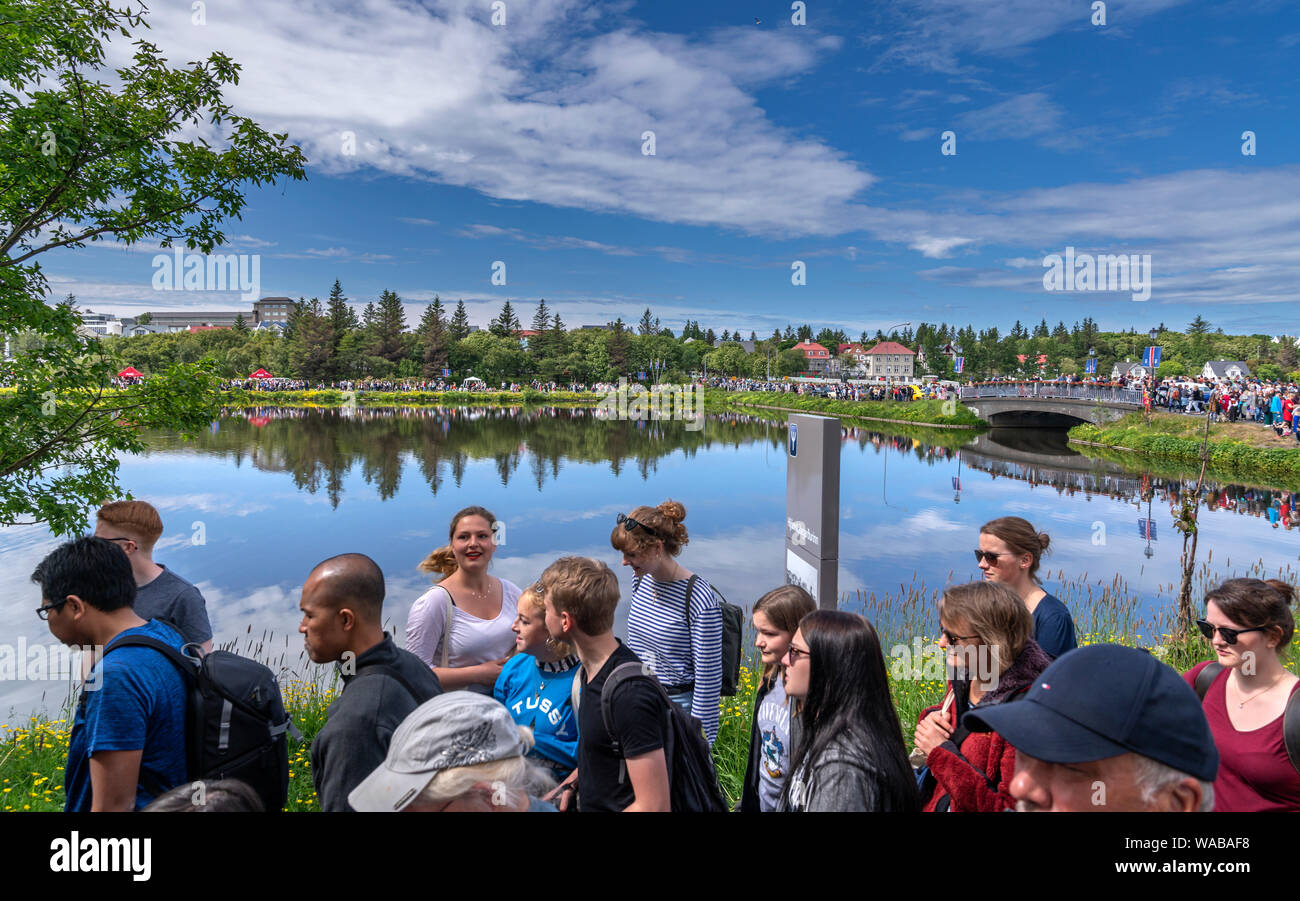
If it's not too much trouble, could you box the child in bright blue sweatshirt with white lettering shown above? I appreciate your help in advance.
[493,585,579,780]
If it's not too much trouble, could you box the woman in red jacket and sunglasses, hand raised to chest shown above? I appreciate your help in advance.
[915,581,1052,813]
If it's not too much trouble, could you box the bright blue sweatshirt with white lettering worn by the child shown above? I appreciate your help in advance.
[493,654,579,770]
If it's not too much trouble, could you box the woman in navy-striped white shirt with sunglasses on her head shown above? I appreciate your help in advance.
[610,501,723,745]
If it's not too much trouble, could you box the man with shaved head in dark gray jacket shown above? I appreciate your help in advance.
[298,554,442,811]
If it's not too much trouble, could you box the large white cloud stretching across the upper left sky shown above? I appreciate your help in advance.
[111,0,874,234]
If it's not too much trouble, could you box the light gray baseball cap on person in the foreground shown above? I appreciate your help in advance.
[347,692,528,813]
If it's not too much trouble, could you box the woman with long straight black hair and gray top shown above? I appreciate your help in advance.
[779,610,918,813]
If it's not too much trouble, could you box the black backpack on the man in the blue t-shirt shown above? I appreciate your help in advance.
[104,634,302,811]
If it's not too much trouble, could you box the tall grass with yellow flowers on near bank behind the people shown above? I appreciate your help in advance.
[0,555,1300,811]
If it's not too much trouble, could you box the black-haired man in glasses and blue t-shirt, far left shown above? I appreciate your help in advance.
[31,538,187,813]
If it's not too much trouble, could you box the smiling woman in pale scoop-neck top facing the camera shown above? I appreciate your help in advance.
[406,507,520,694]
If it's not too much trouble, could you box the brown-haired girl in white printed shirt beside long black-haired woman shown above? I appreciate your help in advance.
[737,585,816,813]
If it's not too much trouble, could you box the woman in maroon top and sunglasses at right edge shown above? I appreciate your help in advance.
[1183,579,1300,811]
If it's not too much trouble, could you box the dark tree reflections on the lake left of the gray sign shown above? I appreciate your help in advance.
[142,407,785,507]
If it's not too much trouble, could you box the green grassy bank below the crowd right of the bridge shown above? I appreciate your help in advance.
[1070,413,1300,485]
